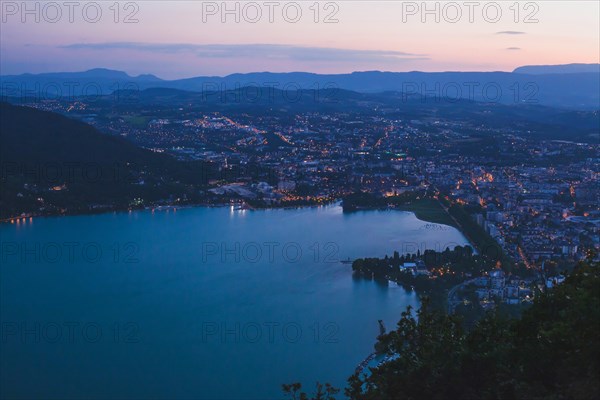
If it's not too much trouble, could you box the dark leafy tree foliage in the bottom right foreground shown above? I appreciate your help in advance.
[346,265,600,400]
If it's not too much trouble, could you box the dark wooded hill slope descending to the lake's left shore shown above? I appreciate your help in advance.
[0,103,202,218]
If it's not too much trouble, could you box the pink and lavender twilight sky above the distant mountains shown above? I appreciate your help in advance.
[0,0,600,79]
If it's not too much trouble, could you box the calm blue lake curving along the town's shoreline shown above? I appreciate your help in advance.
[0,205,466,399]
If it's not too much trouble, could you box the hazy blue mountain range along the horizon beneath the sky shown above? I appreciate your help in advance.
[0,64,600,110]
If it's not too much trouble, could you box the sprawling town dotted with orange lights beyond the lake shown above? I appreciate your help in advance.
[4,92,600,308]
